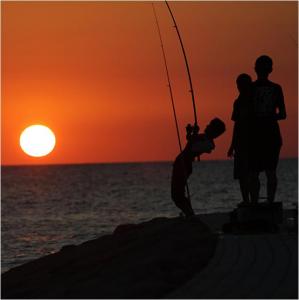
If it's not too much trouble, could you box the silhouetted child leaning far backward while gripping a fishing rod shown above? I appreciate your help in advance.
[171,118,225,217]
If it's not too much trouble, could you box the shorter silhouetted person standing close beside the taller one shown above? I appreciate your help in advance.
[227,74,253,204]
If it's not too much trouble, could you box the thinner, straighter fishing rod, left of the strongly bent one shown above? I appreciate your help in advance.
[152,3,190,200]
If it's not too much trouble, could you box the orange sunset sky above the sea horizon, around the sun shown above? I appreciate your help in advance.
[1,1,298,165]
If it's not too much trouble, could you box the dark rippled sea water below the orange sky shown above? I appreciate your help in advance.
[1,159,298,272]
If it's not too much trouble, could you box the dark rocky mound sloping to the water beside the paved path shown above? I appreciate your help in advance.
[1,218,217,299]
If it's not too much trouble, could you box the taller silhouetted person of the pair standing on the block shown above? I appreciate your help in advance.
[251,55,286,203]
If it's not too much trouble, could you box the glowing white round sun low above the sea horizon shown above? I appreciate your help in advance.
[20,125,56,157]
